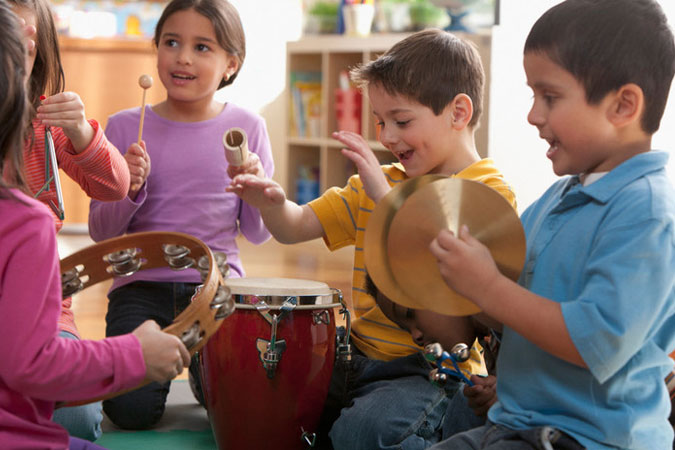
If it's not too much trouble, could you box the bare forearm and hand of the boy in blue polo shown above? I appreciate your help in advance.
[429,226,586,367]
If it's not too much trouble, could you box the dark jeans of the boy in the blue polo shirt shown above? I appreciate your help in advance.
[430,421,584,450]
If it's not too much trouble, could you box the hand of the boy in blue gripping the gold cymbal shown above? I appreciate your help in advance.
[429,225,501,309]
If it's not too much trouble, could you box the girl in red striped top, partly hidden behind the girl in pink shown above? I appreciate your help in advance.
[9,0,129,441]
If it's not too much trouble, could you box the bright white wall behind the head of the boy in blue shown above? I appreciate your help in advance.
[489,0,675,212]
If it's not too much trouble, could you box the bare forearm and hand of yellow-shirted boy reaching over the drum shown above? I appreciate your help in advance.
[227,175,323,244]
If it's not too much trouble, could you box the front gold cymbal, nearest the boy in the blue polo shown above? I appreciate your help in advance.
[367,177,526,316]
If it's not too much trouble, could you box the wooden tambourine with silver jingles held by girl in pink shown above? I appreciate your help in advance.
[61,232,235,406]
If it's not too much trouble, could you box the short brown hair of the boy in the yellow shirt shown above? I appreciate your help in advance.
[350,29,485,127]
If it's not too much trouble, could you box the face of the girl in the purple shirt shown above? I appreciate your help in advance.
[157,9,238,104]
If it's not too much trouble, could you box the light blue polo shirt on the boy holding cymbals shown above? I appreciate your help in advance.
[489,151,675,450]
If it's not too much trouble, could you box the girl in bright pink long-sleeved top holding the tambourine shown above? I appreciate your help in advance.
[0,8,190,449]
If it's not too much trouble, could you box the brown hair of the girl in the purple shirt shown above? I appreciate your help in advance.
[153,0,246,89]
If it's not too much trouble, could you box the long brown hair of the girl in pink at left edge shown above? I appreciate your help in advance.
[0,2,28,198]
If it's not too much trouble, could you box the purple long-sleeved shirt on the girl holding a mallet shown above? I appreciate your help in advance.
[89,103,274,289]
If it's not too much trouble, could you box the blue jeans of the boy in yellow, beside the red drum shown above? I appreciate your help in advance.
[319,346,461,450]
